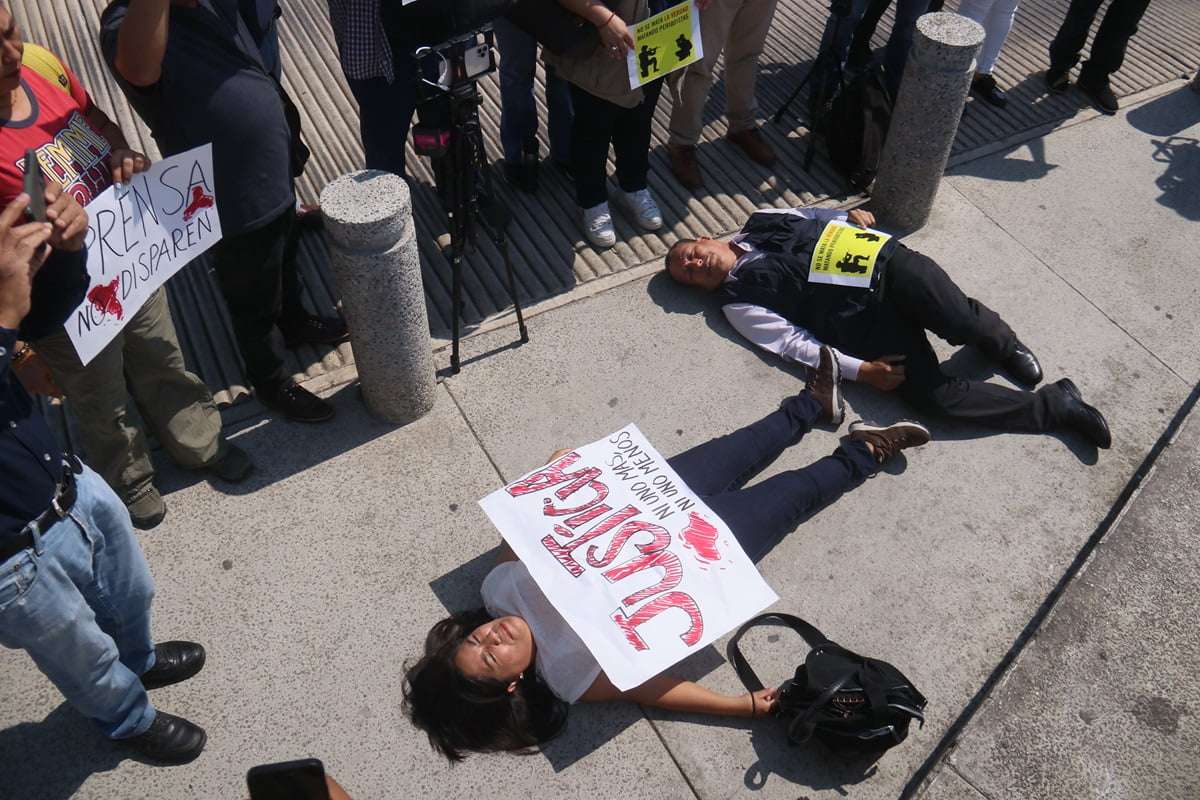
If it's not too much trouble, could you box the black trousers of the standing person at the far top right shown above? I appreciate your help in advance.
[1050,0,1150,80]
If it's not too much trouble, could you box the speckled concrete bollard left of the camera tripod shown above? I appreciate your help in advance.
[320,169,437,425]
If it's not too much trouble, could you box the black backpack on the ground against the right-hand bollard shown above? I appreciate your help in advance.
[824,64,893,192]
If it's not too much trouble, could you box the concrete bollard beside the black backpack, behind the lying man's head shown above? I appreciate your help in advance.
[870,12,984,231]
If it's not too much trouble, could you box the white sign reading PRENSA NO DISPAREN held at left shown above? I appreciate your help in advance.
[66,144,221,363]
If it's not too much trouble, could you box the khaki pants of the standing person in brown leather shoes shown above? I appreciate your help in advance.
[667,0,776,145]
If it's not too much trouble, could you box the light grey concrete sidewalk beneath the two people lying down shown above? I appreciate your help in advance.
[0,82,1200,800]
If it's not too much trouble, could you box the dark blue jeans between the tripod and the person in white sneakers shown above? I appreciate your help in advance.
[492,17,571,164]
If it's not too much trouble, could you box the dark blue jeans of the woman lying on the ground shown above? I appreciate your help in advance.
[667,392,880,561]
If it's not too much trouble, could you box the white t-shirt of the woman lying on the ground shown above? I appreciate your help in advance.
[482,561,600,703]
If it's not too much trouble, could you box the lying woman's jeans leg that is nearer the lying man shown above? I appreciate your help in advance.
[667,391,821,498]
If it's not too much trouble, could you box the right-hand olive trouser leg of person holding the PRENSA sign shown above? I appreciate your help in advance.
[124,289,224,469]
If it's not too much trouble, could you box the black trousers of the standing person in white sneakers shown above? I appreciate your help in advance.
[571,79,662,209]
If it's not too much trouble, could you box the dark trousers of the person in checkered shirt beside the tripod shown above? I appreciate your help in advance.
[346,63,416,176]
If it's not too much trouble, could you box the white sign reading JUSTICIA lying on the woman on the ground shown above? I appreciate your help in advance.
[479,425,778,690]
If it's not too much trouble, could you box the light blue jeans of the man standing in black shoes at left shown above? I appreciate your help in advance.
[0,467,155,739]
